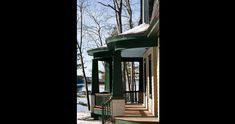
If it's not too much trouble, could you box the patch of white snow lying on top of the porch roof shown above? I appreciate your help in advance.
[120,23,149,35]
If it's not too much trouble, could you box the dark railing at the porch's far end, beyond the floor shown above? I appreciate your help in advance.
[124,91,143,104]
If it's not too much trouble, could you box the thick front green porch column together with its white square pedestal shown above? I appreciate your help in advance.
[111,51,125,117]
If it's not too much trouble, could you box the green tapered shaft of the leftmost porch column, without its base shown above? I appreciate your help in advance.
[91,59,99,95]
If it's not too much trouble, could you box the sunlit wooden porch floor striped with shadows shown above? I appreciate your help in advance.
[115,104,159,122]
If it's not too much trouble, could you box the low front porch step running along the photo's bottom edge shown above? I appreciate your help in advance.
[115,117,159,124]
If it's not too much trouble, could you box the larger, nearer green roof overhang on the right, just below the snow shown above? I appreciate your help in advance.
[106,18,159,51]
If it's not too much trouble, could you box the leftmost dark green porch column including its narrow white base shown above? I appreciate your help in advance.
[90,59,99,118]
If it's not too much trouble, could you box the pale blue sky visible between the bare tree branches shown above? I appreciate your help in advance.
[77,0,140,77]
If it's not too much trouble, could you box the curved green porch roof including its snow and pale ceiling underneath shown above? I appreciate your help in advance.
[87,18,159,59]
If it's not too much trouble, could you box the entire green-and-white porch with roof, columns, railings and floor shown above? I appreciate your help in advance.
[87,8,159,124]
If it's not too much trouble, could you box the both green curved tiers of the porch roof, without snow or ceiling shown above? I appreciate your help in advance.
[87,18,159,57]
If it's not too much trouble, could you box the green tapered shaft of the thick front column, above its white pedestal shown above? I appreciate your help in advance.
[112,51,124,98]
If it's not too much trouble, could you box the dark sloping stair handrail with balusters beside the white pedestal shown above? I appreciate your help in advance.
[102,97,112,124]
